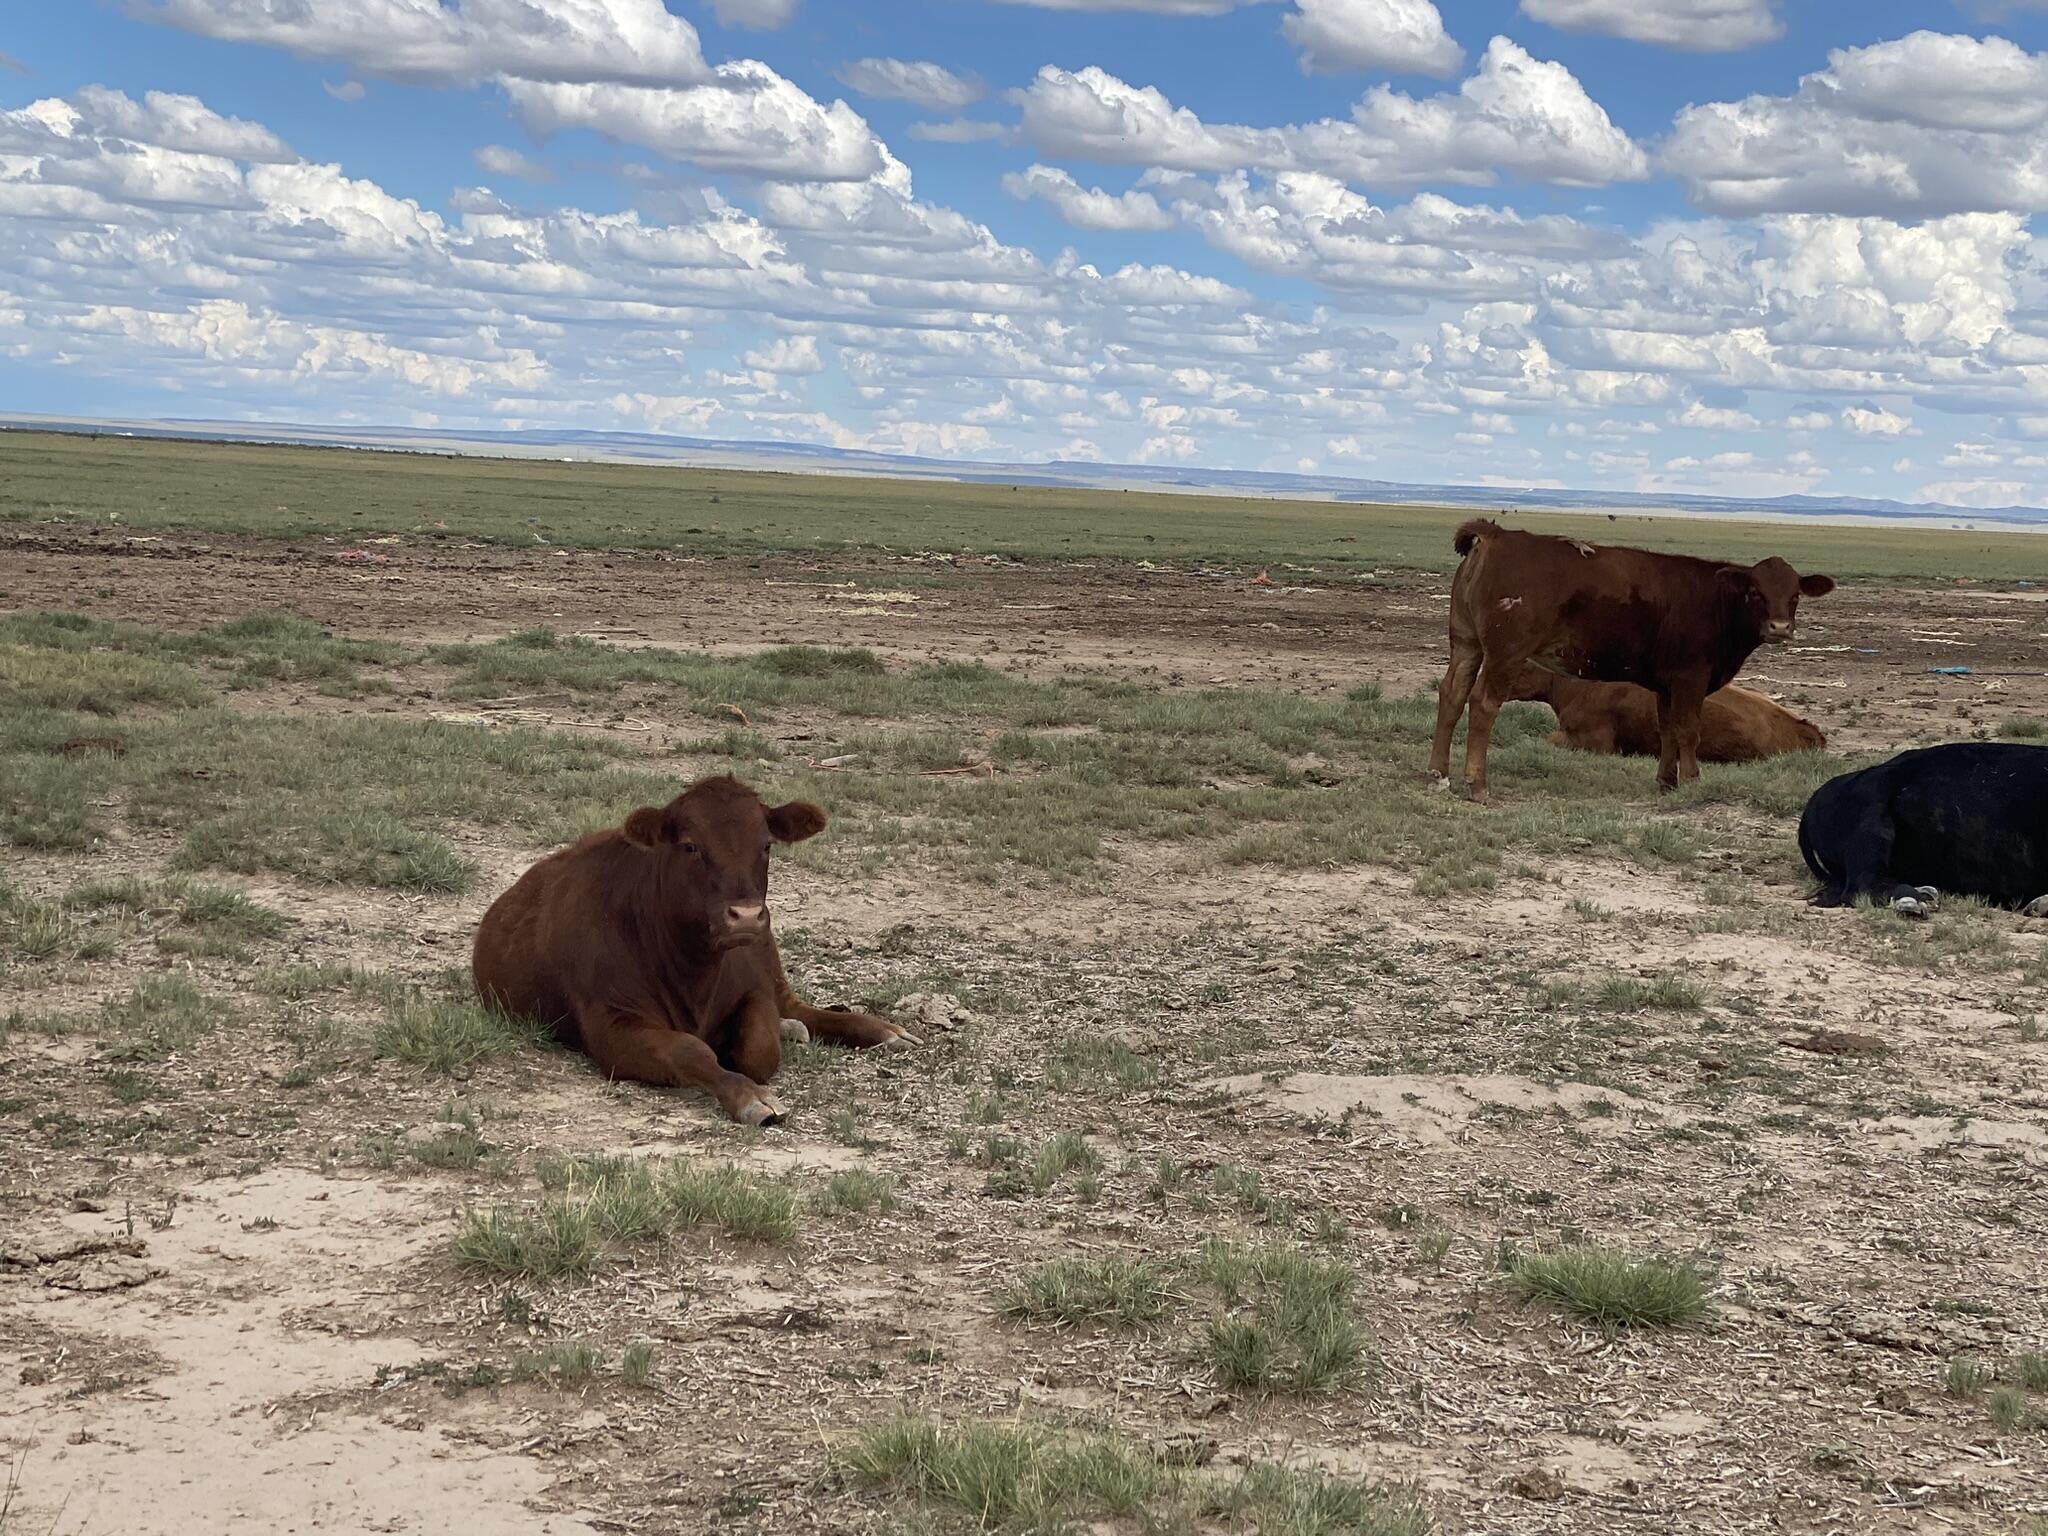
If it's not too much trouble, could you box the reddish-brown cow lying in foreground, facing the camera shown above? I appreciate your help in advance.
[473,776,911,1124]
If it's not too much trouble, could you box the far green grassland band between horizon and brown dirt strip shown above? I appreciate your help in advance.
[0,432,2048,582]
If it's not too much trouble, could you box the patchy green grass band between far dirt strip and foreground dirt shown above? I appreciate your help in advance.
[0,614,1841,895]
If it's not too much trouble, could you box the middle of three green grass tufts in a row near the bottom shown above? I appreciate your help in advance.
[1196,1239,1366,1393]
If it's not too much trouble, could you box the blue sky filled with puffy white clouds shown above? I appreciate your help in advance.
[0,0,2048,506]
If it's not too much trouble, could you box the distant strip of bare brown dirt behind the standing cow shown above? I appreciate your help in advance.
[12,526,2048,752]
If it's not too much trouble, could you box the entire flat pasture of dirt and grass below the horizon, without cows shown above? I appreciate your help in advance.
[0,434,2048,1536]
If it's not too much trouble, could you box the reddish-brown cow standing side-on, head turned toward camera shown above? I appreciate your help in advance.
[1430,518,1835,801]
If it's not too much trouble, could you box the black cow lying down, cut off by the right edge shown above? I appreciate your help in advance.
[1798,741,2048,918]
